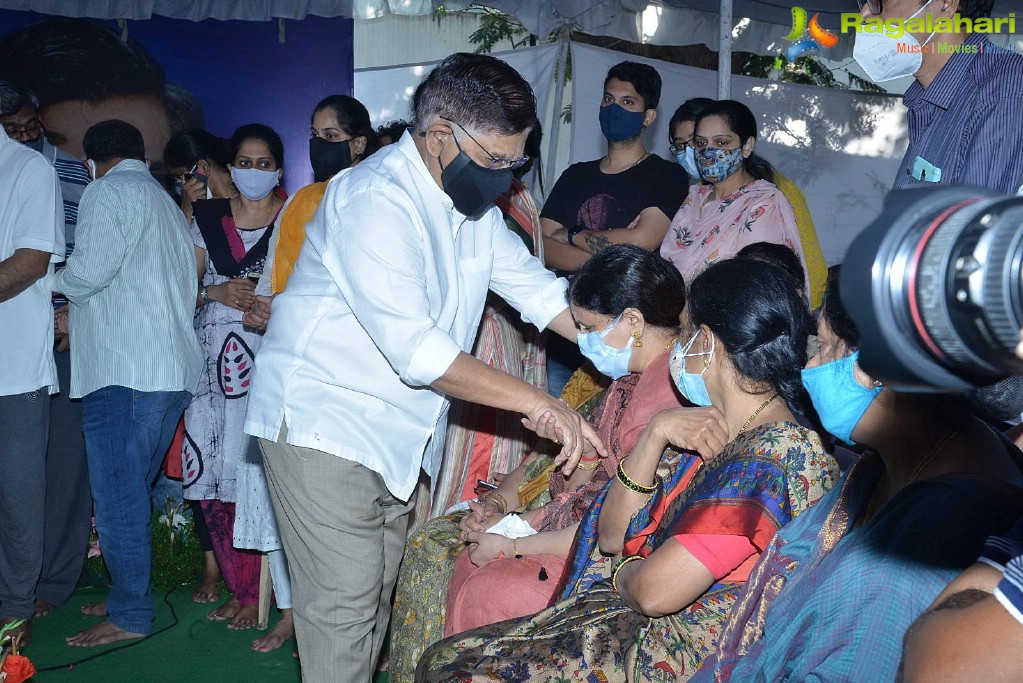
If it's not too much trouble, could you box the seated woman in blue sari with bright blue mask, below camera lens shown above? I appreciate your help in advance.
[695,269,1023,681]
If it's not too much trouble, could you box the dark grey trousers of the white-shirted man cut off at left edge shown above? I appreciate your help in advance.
[0,388,50,618]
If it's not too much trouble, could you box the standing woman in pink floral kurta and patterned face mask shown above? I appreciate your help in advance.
[661,100,812,292]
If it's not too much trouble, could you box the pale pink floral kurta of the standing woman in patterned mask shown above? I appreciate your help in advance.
[661,180,810,291]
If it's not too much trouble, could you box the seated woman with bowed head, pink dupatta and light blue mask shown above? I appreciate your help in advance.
[445,245,684,635]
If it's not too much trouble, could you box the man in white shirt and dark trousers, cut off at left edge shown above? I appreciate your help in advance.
[0,100,64,644]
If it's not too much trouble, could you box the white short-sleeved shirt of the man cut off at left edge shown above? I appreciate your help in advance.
[0,129,64,396]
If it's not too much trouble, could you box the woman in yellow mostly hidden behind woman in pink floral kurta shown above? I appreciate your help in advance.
[668,97,828,310]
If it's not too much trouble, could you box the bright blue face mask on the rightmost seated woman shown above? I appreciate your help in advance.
[802,351,882,444]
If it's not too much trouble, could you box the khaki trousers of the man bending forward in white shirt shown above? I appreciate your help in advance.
[259,425,415,683]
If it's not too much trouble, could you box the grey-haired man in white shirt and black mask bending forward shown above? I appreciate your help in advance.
[246,54,604,682]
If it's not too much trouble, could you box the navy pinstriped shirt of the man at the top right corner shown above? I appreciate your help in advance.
[894,34,1023,194]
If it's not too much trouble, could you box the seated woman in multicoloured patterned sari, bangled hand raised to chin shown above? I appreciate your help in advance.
[417,260,838,681]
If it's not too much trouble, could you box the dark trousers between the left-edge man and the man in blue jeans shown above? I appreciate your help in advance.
[36,351,92,606]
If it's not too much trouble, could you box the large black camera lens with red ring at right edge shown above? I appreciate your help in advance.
[842,186,1023,391]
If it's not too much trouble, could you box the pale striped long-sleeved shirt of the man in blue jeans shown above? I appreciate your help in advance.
[54,160,203,399]
